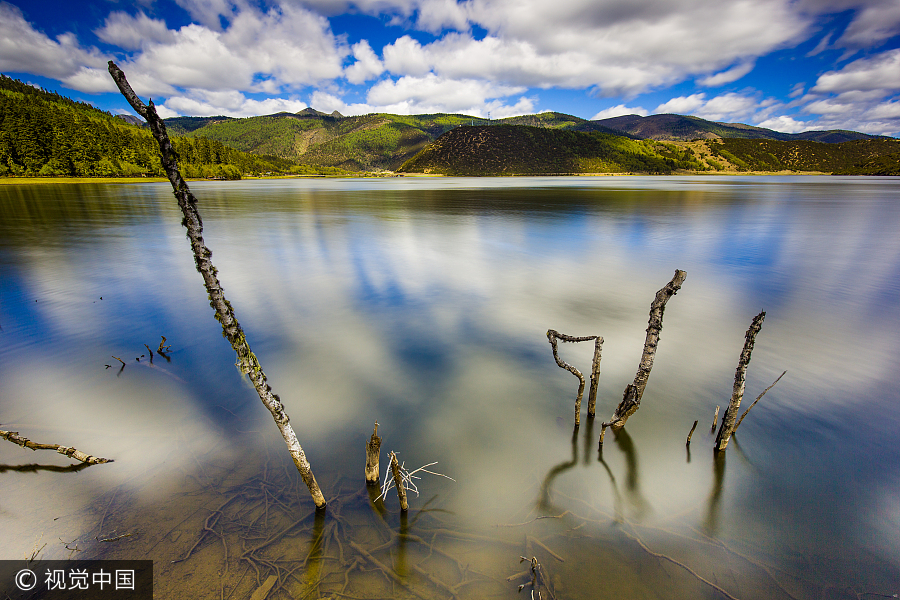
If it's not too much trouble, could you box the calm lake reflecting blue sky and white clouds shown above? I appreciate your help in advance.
[0,176,900,600]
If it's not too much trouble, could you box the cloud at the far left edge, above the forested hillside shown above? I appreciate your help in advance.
[0,2,109,82]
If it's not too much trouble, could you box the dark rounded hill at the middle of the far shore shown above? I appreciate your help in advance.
[399,125,705,175]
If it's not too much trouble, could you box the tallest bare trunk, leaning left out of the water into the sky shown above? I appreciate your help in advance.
[109,61,325,509]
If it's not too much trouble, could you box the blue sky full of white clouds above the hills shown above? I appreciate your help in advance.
[0,0,900,136]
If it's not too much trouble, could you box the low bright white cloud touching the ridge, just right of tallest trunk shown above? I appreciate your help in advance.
[157,90,307,118]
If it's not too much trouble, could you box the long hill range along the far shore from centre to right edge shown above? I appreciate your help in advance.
[399,125,900,175]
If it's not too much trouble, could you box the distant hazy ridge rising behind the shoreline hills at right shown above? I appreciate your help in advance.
[591,115,878,144]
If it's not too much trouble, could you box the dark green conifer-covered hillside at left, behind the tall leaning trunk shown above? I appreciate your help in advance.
[0,75,291,179]
